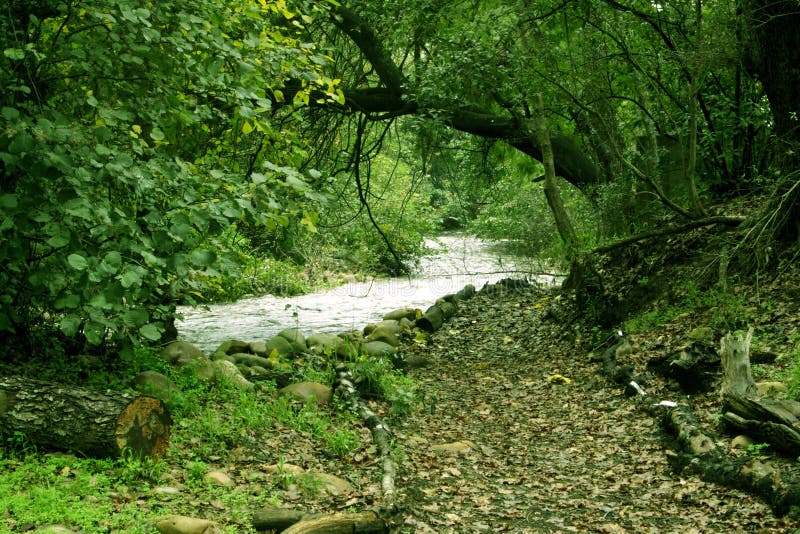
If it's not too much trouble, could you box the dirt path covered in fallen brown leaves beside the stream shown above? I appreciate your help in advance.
[393,290,796,533]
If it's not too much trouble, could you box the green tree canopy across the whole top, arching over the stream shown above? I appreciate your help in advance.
[0,0,800,354]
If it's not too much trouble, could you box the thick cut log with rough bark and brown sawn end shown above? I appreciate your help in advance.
[0,377,171,458]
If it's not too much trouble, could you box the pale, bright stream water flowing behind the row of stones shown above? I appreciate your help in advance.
[177,236,553,352]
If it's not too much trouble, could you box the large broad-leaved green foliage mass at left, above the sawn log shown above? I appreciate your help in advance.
[0,0,339,352]
